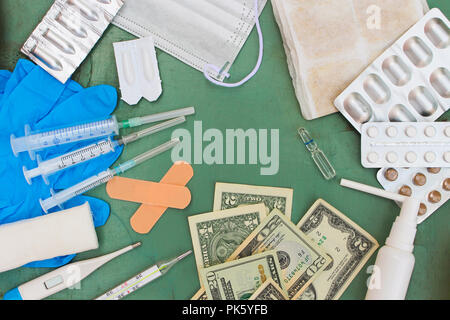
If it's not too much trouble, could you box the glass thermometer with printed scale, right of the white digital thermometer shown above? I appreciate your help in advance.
[95,250,192,300]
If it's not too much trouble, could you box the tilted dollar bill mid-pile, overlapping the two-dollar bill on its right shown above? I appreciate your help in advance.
[228,209,331,297]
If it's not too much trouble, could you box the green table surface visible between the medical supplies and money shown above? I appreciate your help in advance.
[0,0,450,299]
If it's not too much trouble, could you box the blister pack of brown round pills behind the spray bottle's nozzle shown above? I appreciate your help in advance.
[377,168,450,223]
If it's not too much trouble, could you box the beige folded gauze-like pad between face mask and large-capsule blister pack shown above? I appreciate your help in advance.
[272,0,428,120]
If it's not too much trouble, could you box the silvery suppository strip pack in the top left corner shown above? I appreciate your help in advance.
[21,0,123,83]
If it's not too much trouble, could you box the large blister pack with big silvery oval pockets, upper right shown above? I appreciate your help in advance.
[334,8,450,132]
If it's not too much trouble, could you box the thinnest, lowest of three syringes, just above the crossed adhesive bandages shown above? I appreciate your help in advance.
[39,138,180,213]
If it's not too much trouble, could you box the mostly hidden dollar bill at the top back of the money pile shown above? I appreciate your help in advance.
[214,182,294,219]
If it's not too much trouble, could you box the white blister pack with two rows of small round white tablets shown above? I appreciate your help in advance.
[361,122,450,168]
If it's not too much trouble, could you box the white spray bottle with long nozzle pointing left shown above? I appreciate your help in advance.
[341,179,420,300]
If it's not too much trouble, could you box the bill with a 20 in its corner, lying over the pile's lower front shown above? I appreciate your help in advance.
[200,251,283,300]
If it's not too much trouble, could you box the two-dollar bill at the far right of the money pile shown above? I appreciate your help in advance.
[293,199,378,300]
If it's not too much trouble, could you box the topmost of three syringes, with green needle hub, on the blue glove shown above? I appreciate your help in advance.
[10,107,195,160]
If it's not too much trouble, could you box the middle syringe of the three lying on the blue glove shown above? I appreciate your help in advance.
[23,116,186,184]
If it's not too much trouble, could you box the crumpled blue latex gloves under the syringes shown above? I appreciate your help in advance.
[0,60,123,267]
